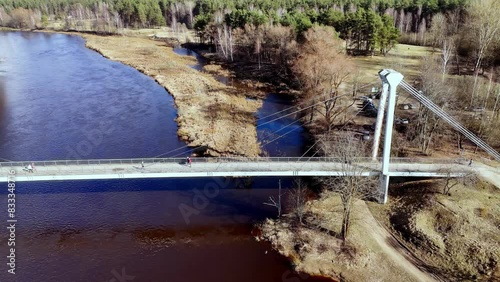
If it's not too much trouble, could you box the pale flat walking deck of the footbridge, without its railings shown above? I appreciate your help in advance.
[0,160,470,182]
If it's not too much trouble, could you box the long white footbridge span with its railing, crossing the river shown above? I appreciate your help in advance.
[0,157,472,182]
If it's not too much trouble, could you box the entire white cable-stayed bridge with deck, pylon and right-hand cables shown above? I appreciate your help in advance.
[0,70,500,203]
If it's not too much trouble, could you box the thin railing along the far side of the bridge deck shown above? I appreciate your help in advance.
[0,157,467,167]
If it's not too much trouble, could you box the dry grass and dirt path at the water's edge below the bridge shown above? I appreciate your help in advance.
[258,192,431,282]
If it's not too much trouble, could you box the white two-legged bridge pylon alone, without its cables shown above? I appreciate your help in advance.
[373,69,403,204]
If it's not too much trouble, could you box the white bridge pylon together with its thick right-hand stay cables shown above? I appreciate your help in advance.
[372,69,500,204]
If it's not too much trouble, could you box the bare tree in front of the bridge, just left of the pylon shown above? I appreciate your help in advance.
[322,136,379,241]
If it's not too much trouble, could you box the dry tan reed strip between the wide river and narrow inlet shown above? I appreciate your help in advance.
[78,33,262,156]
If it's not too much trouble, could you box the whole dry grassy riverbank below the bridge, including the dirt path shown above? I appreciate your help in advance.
[257,176,500,281]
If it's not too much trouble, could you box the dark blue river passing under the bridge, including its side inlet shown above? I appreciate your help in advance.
[0,32,330,282]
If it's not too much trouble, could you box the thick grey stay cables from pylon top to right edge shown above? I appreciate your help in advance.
[401,81,500,161]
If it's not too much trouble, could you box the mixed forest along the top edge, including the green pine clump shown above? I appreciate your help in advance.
[0,0,468,46]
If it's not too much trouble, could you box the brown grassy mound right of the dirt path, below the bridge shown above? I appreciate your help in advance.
[371,182,500,281]
